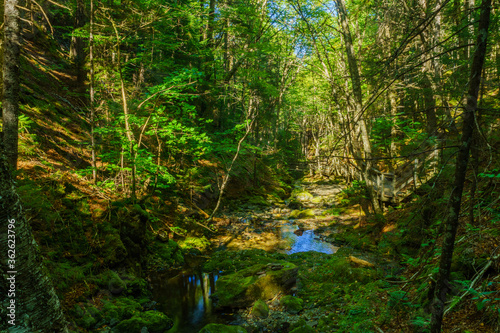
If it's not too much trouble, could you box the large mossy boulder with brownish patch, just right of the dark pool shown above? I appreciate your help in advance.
[213,261,298,308]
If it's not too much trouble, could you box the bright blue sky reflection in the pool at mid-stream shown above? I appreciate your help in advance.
[279,223,338,254]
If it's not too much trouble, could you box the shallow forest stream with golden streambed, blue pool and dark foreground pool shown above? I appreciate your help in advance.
[151,185,340,333]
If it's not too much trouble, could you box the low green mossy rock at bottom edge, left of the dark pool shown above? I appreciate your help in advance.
[113,311,173,333]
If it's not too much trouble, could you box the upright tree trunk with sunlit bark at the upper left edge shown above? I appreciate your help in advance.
[2,0,21,169]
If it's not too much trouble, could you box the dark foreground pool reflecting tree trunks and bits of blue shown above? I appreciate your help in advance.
[151,271,219,333]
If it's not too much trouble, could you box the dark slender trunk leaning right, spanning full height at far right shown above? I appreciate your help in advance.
[431,0,491,333]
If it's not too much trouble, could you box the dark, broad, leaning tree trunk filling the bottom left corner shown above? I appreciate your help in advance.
[0,152,67,332]
